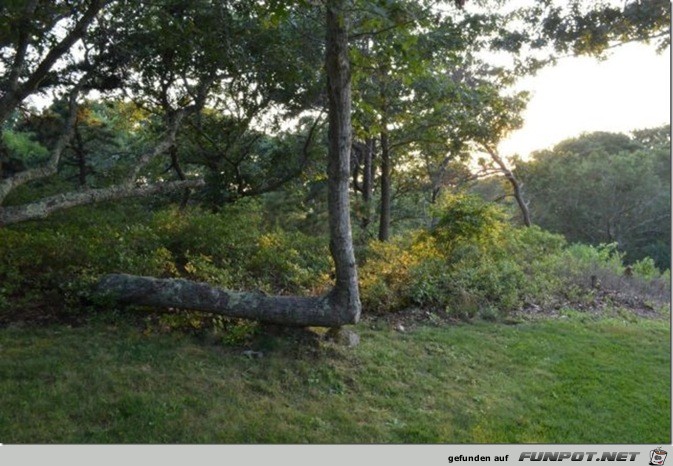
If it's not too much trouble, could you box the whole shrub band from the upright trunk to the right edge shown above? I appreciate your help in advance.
[360,196,670,318]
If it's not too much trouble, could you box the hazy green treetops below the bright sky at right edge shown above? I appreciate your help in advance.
[517,126,671,270]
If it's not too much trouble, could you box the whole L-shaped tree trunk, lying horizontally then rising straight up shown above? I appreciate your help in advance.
[98,0,361,327]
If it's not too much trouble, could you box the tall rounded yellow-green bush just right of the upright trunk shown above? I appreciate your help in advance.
[360,195,526,317]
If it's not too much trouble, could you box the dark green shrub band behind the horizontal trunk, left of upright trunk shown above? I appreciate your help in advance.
[0,202,331,321]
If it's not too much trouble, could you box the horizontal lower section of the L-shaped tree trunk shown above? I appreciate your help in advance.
[96,274,360,327]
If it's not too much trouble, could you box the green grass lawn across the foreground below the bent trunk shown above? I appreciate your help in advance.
[0,316,671,444]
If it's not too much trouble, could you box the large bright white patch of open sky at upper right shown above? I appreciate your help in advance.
[498,43,671,159]
